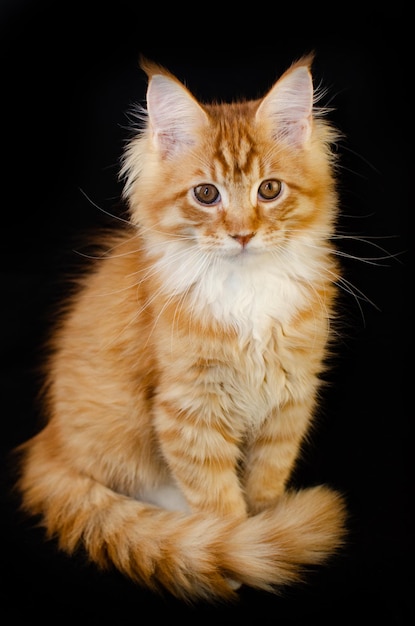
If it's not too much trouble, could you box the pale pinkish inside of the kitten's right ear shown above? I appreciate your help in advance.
[256,60,313,147]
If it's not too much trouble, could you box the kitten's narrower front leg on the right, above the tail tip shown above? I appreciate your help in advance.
[243,400,314,514]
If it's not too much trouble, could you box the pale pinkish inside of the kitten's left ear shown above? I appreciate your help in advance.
[147,67,208,158]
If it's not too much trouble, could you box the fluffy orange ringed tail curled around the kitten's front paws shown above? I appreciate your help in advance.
[19,438,345,601]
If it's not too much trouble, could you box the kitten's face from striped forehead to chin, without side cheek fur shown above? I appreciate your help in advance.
[171,105,322,257]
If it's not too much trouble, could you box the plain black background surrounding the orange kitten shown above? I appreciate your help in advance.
[0,0,414,624]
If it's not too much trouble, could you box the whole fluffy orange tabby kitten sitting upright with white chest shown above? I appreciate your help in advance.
[17,54,347,602]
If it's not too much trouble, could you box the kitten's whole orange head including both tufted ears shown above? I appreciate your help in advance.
[122,55,342,258]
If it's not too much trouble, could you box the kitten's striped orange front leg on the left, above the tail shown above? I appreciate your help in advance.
[155,398,247,518]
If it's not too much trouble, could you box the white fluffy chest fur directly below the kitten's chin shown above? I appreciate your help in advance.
[157,245,310,341]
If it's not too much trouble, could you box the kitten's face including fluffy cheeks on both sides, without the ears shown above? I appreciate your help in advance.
[130,105,334,258]
